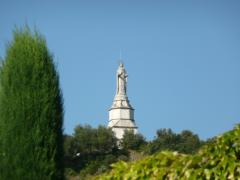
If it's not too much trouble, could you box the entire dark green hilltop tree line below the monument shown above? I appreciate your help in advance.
[64,125,206,177]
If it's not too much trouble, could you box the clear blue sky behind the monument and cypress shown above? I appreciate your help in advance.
[0,0,240,139]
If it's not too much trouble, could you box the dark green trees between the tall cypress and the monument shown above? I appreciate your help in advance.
[64,125,127,179]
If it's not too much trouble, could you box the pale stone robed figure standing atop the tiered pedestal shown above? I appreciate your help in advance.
[117,63,128,94]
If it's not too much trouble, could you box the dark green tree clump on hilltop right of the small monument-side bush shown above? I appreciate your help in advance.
[145,129,202,154]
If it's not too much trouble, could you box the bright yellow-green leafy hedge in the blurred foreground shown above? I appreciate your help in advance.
[95,125,240,180]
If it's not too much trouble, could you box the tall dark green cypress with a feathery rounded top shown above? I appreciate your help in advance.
[0,27,64,180]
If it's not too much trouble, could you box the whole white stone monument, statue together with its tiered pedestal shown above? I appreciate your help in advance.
[108,63,137,139]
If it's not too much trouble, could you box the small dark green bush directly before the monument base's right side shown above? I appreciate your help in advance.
[120,130,147,150]
